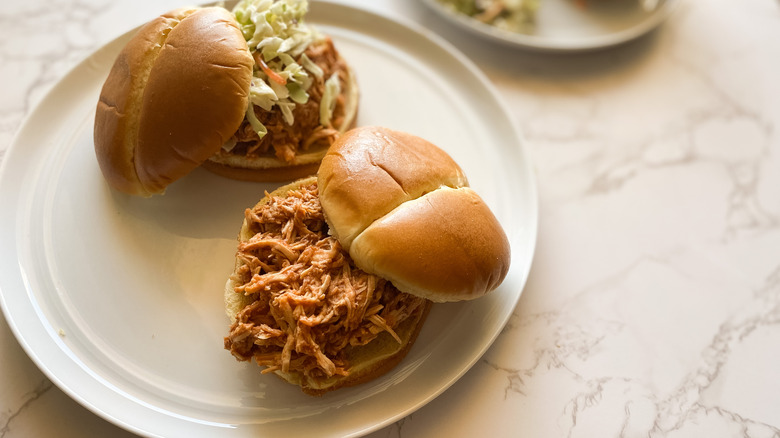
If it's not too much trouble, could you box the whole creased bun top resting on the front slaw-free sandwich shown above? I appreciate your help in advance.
[318,127,510,301]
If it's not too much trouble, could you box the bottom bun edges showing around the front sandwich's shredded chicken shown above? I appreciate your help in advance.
[224,177,431,395]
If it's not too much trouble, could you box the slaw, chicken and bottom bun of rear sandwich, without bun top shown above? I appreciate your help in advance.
[204,0,358,181]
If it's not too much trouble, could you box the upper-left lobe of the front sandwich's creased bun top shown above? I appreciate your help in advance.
[318,126,468,251]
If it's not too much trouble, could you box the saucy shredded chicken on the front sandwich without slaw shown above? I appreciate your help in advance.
[225,183,425,381]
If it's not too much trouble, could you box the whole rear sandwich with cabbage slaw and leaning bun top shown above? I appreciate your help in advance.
[94,0,358,196]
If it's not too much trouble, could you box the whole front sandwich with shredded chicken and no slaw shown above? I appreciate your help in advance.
[224,127,510,395]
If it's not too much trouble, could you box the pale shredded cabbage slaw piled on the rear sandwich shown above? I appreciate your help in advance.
[233,0,327,138]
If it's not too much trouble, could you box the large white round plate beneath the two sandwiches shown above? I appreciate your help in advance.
[0,2,537,438]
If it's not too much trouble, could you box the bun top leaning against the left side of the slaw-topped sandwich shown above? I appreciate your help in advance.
[94,7,254,196]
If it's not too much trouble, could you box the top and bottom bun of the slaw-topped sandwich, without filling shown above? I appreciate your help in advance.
[94,3,359,196]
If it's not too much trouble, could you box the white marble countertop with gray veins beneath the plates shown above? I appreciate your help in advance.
[0,0,780,438]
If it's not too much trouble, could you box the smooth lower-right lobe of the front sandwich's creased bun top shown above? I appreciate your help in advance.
[350,187,509,301]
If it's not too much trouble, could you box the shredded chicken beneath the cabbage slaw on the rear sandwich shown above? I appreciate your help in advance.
[221,37,348,163]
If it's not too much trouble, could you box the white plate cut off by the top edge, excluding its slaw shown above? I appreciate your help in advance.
[423,0,678,52]
